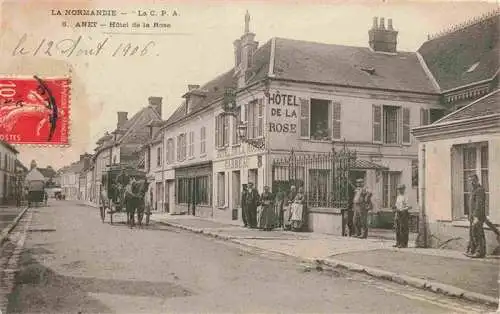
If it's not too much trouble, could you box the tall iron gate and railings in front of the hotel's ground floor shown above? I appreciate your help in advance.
[272,147,356,209]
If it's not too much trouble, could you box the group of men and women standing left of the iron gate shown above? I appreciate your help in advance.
[241,183,307,231]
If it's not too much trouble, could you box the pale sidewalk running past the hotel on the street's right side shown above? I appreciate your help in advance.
[151,213,500,305]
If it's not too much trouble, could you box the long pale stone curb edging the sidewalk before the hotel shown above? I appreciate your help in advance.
[157,221,499,306]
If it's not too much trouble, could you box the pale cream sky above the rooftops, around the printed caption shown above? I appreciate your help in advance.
[0,0,498,168]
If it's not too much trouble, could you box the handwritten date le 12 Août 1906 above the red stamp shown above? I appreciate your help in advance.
[12,34,156,58]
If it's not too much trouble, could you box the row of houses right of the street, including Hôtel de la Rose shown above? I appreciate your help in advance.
[64,11,500,253]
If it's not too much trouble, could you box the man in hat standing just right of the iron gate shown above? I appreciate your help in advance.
[352,179,371,239]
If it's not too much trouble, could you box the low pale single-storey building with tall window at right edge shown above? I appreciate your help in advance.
[414,90,500,250]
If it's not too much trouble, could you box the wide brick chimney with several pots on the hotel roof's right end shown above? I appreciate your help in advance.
[368,17,398,53]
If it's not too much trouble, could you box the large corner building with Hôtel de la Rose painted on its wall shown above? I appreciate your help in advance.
[145,16,454,233]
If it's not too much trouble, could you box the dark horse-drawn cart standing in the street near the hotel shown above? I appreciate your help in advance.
[99,165,149,225]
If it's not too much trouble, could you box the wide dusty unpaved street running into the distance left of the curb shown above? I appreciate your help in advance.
[0,200,492,313]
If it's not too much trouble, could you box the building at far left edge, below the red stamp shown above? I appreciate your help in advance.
[0,141,19,204]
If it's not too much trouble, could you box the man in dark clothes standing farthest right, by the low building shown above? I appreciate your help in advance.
[466,174,486,258]
